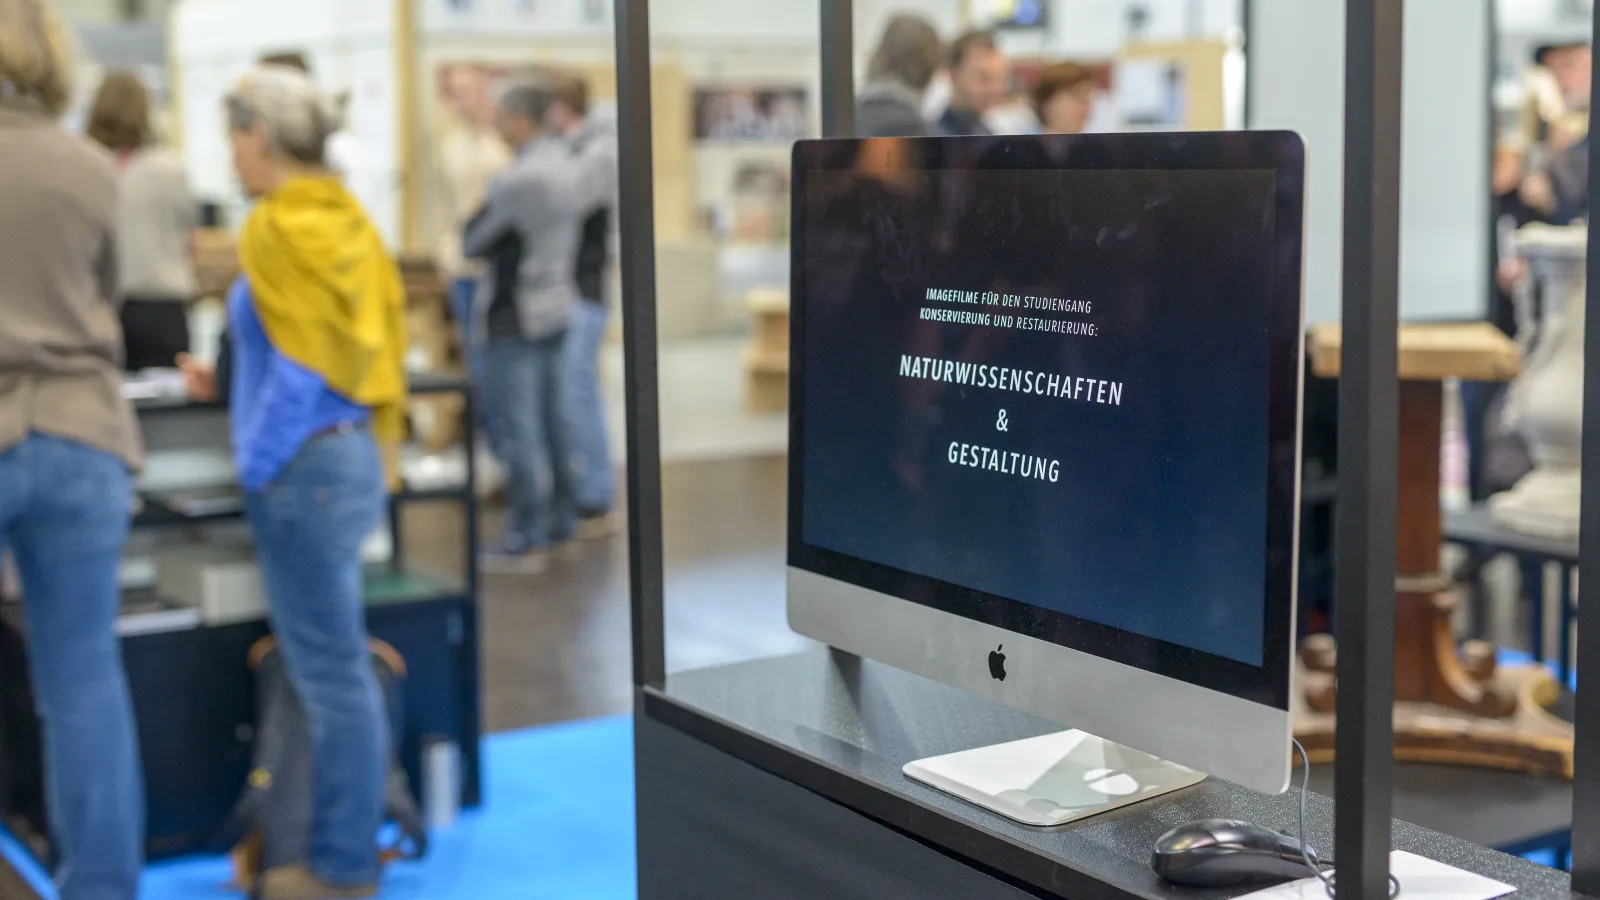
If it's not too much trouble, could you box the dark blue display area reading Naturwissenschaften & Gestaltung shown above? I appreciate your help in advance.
[795,157,1298,666]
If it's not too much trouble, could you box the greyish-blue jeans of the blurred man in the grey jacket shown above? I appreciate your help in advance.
[483,335,578,549]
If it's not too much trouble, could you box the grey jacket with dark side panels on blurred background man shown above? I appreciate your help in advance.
[461,138,584,340]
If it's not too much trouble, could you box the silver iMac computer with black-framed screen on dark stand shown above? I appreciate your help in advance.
[787,131,1304,825]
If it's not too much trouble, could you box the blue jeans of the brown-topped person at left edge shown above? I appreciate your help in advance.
[0,434,144,900]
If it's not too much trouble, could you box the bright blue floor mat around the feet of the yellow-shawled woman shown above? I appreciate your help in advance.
[144,716,637,900]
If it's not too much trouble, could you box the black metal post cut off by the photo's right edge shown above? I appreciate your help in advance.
[1573,5,1600,897]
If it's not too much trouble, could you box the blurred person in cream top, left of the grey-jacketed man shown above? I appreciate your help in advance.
[434,66,510,435]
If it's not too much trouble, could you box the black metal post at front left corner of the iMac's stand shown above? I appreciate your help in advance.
[614,0,667,687]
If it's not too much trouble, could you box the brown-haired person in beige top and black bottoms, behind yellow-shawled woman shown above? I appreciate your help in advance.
[86,70,200,372]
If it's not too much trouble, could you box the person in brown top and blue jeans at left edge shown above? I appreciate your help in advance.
[0,0,144,900]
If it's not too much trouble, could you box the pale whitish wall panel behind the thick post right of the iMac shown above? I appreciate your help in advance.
[1248,0,1490,322]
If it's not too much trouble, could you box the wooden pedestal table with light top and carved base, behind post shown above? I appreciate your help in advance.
[1294,322,1573,778]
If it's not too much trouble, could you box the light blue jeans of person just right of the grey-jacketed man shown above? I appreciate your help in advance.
[565,299,616,516]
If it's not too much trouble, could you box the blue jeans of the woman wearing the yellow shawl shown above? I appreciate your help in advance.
[245,428,389,886]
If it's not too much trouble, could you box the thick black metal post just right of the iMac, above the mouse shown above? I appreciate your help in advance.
[1334,0,1405,900]
